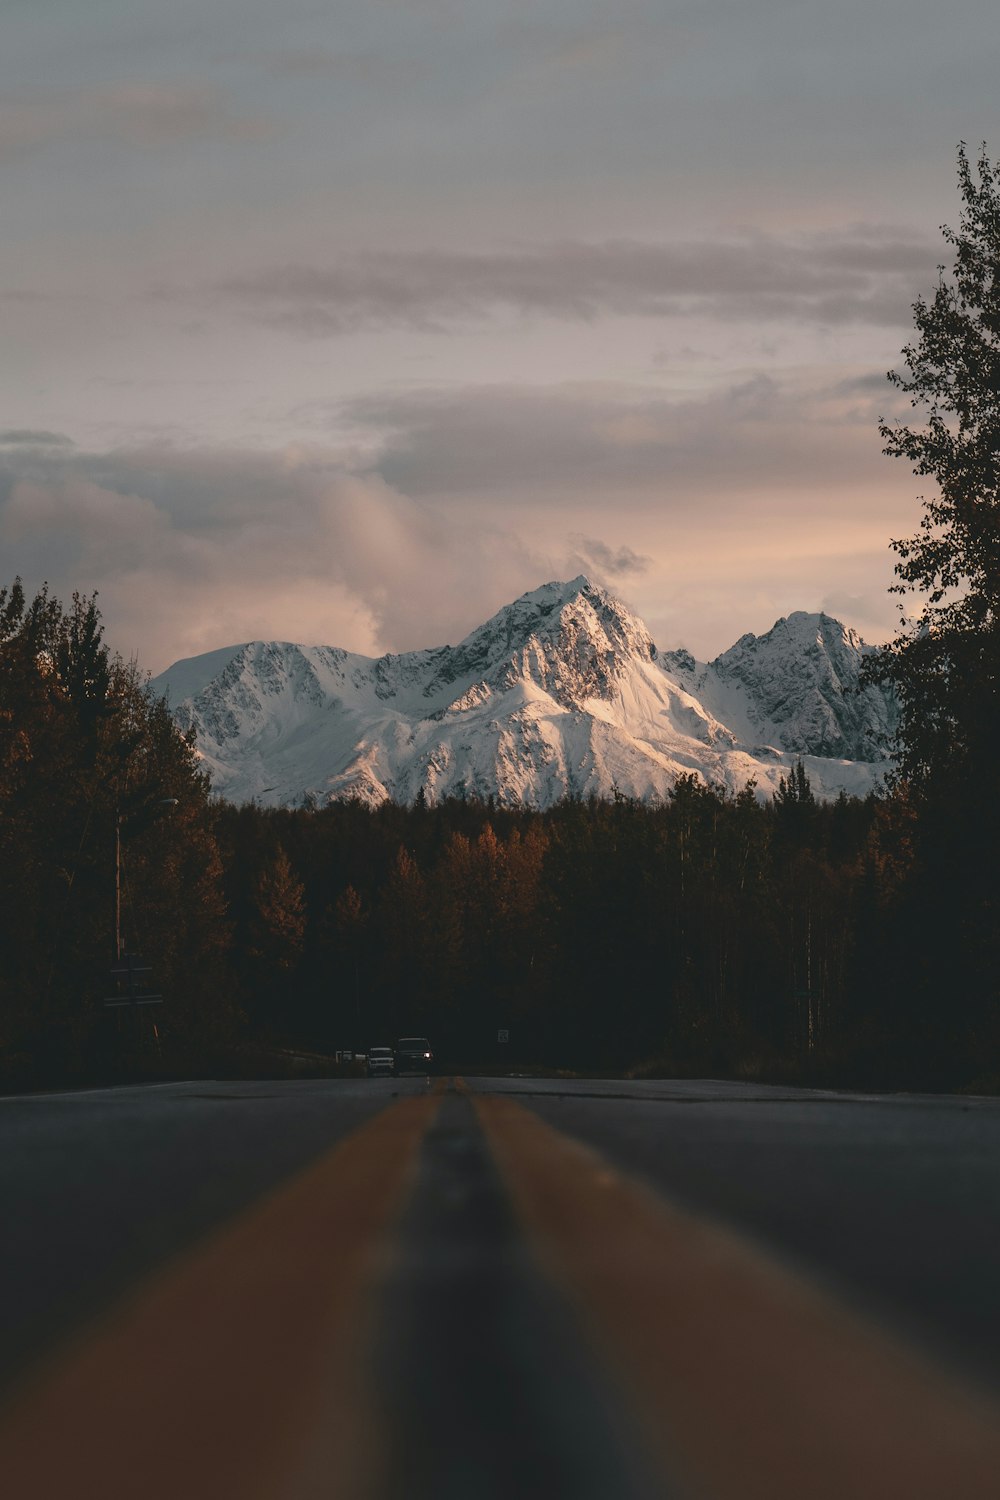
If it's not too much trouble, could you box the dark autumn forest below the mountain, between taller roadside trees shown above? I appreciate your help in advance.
[211,767,990,1086]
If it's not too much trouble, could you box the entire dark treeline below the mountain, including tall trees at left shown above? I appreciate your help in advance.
[0,584,999,1086]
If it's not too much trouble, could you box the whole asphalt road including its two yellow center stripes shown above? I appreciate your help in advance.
[0,1077,1000,1500]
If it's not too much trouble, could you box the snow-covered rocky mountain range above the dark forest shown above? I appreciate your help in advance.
[153,578,897,807]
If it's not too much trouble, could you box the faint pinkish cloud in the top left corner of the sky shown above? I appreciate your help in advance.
[0,81,268,159]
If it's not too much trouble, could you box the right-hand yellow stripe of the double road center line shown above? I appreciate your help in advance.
[475,1095,1000,1500]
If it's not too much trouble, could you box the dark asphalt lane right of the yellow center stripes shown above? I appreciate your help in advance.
[470,1079,1000,1386]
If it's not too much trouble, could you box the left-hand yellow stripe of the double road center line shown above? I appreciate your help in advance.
[0,1095,439,1500]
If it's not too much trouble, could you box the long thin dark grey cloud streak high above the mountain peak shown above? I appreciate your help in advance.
[213,225,939,338]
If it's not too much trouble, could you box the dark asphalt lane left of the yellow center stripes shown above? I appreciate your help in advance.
[0,1079,401,1382]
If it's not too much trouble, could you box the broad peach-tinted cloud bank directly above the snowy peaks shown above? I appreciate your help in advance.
[0,371,913,671]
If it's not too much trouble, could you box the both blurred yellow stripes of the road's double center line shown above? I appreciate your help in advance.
[0,1083,1000,1500]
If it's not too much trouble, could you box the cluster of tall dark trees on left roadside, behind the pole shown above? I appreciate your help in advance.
[0,581,235,1083]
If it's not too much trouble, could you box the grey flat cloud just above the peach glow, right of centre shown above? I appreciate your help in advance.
[337,372,892,507]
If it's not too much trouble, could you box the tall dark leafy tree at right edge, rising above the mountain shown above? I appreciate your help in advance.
[868,146,1000,1082]
